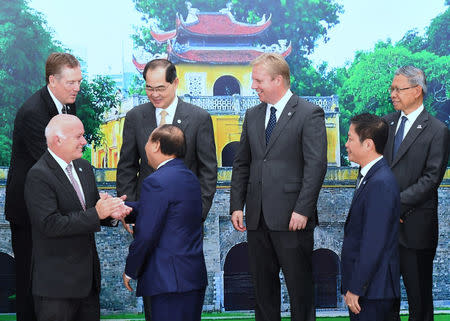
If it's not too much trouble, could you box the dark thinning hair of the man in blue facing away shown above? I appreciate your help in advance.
[150,124,186,158]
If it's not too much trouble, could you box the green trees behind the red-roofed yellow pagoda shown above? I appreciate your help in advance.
[133,0,343,95]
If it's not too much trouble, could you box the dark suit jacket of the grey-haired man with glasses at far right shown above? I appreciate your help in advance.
[384,110,449,249]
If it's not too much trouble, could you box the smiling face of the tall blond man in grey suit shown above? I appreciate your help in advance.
[252,64,287,105]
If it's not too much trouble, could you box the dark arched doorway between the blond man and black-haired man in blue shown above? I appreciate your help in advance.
[312,249,341,308]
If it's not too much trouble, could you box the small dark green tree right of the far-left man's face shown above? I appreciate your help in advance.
[77,76,120,145]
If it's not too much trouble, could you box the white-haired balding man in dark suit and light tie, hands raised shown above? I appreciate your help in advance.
[25,115,131,321]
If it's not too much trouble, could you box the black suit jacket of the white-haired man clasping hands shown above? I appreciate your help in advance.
[25,151,100,298]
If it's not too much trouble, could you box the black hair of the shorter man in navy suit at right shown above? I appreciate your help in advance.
[350,113,389,154]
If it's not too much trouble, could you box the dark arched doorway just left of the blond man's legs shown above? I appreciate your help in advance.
[223,242,255,311]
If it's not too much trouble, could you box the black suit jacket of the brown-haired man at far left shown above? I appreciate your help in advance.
[5,86,75,225]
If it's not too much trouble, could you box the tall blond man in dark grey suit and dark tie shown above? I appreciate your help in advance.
[230,54,327,321]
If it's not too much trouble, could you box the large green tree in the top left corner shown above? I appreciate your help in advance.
[0,0,59,166]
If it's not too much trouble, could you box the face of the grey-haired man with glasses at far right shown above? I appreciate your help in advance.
[391,75,423,115]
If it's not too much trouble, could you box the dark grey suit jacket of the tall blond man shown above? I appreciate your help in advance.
[230,95,327,231]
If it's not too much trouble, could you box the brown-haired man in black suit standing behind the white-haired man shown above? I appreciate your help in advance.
[5,53,82,321]
